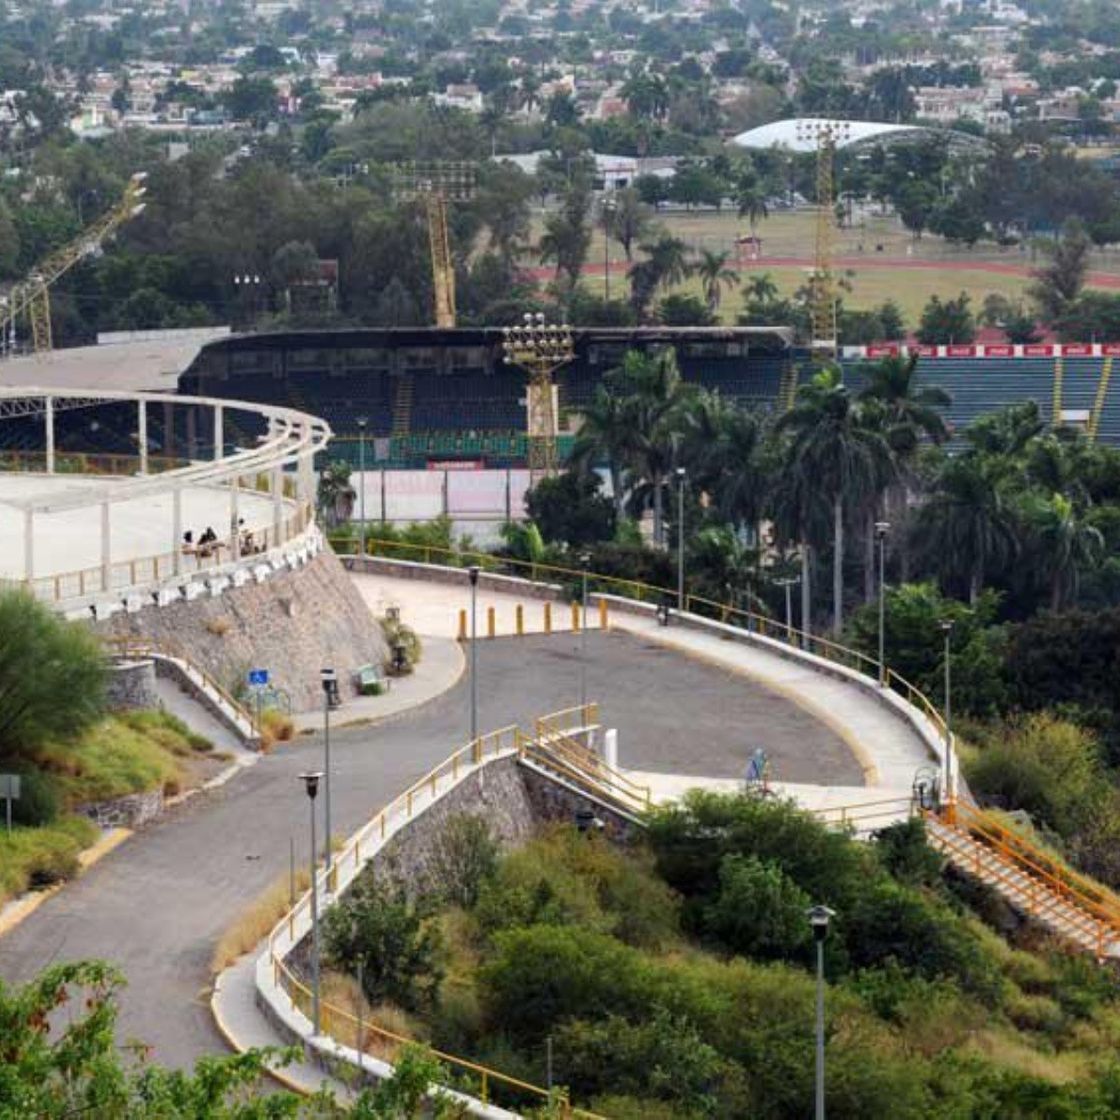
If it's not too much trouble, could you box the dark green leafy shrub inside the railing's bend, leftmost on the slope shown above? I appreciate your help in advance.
[323,877,442,1011]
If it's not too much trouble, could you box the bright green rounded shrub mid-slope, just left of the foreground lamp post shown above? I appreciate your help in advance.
[704,856,811,960]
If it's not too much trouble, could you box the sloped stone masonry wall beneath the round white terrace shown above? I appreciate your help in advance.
[93,552,385,711]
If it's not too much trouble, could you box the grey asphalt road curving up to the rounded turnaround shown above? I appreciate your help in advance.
[0,633,846,1065]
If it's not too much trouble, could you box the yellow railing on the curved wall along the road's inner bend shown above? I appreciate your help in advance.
[268,704,606,1120]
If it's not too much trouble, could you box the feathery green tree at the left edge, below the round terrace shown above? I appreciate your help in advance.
[0,591,105,758]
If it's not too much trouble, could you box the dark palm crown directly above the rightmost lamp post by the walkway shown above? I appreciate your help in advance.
[917,452,1019,604]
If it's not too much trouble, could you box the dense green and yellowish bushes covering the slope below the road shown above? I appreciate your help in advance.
[327,810,1120,1120]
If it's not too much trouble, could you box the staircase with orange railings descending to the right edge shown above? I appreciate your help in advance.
[925,804,1120,961]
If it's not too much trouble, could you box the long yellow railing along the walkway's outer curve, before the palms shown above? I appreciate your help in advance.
[330,538,945,736]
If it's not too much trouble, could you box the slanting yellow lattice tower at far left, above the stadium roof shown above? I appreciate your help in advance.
[0,172,148,355]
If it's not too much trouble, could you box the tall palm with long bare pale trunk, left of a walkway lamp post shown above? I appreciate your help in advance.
[777,366,893,634]
